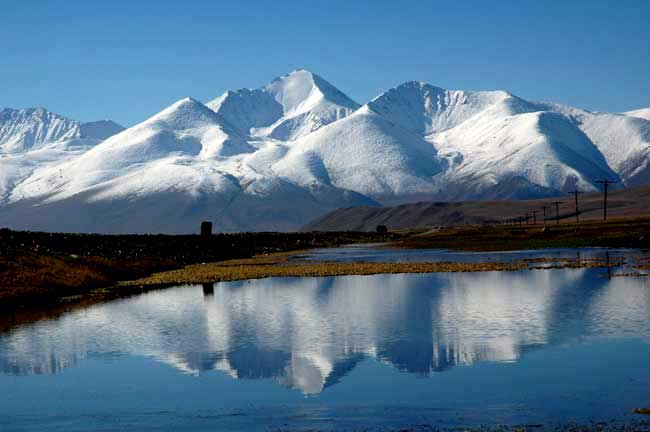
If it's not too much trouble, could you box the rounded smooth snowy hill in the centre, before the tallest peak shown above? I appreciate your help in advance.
[273,107,441,200]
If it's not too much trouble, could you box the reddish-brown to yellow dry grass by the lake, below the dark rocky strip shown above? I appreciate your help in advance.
[0,245,636,331]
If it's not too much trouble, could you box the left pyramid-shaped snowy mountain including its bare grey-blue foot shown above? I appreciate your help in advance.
[0,98,375,233]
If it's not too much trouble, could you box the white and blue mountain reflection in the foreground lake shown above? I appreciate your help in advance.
[0,269,650,394]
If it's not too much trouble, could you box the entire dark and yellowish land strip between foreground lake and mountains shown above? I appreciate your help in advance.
[0,219,650,331]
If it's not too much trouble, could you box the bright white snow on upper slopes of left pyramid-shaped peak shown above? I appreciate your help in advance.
[12,98,253,200]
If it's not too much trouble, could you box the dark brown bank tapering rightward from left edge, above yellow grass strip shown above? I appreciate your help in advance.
[0,230,397,309]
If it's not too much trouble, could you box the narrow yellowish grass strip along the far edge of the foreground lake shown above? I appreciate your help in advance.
[0,250,636,332]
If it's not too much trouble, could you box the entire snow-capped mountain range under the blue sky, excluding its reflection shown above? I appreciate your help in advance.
[0,70,650,233]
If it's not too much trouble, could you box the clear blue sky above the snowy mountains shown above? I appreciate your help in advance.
[0,0,650,126]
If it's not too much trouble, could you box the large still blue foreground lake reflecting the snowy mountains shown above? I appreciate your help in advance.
[0,269,650,431]
